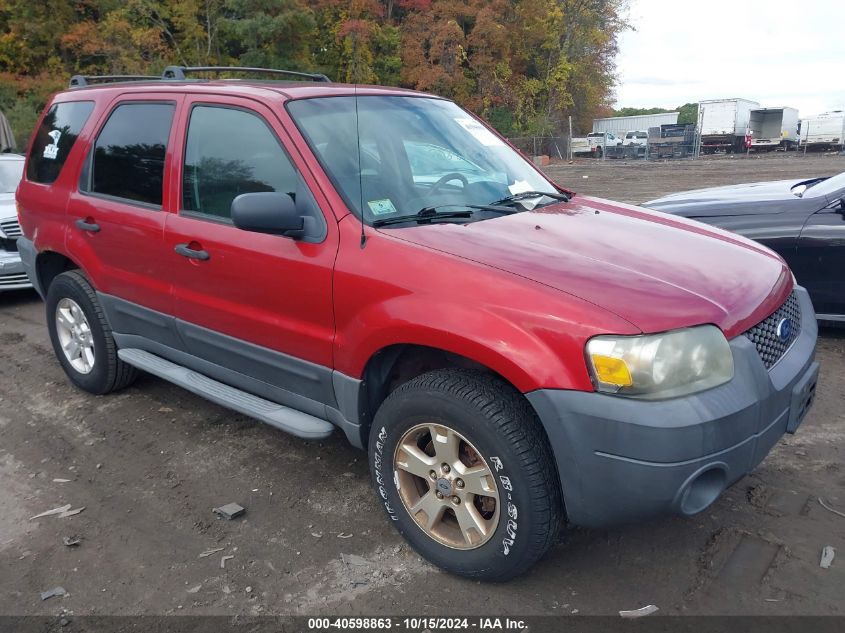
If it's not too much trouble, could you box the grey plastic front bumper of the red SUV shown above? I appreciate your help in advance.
[527,287,819,527]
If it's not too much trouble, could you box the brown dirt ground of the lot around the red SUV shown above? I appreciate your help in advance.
[0,155,845,615]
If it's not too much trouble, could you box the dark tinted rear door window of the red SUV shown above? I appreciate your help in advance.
[88,103,176,207]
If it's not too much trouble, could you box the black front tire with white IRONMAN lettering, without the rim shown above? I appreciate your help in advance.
[369,369,563,582]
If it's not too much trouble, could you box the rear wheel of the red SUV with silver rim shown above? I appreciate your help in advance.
[46,270,137,394]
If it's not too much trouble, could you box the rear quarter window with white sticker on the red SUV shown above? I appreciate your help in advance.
[26,101,94,184]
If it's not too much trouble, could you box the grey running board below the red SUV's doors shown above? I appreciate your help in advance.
[117,349,334,440]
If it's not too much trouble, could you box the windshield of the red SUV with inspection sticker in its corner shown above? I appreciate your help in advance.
[287,96,558,222]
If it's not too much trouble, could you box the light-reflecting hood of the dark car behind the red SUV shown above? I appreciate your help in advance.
[643,178,817,218]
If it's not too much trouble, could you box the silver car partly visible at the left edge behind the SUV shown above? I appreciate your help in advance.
[0,154,32,291]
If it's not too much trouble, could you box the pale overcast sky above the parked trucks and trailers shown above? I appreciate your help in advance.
[616,0,845,116]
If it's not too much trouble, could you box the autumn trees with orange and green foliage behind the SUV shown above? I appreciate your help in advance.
[0,0,627,145]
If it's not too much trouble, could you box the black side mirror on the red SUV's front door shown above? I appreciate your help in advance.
[232,191,305,240]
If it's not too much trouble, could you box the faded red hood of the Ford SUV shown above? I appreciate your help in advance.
[381,196,792,338]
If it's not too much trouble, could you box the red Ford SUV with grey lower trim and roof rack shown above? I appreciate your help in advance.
[17,67,818,580]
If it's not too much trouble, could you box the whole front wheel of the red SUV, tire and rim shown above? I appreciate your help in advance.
[369,369,562,581]
